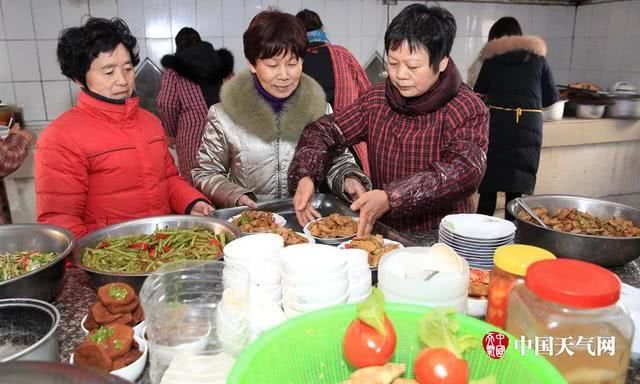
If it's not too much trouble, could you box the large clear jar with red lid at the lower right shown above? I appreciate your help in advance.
[505,259,633,384]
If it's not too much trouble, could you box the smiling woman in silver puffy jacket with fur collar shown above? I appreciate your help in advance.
[191,10,371,208]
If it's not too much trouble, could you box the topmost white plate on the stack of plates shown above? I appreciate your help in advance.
[440,213,516,240]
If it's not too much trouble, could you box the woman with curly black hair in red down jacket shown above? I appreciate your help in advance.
[35,18,213,238]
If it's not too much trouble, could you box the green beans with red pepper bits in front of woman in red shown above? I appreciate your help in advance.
[81,228,227,273]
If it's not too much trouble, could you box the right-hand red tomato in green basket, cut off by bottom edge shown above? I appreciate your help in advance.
[413,348,469,384]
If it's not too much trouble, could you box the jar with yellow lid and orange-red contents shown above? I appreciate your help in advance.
[485,244,555,328]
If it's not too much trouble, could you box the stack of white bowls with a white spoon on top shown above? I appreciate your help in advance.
[378,243,469,313]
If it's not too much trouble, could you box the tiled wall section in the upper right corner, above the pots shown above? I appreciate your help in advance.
[569,0,640,88]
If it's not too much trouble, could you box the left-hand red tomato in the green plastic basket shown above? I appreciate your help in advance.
[342,316,396,368]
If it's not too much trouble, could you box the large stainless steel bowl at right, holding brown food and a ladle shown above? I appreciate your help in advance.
[507,195,640,267]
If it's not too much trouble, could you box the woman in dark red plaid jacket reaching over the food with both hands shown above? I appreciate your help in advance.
[288,4,489,235]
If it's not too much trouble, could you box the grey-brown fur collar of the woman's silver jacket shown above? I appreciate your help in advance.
[220,70,327,142]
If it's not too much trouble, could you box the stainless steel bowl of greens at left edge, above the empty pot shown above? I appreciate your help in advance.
[0,224,75,301]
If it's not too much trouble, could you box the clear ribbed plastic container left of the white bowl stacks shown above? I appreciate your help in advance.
[139,261,249,384]
